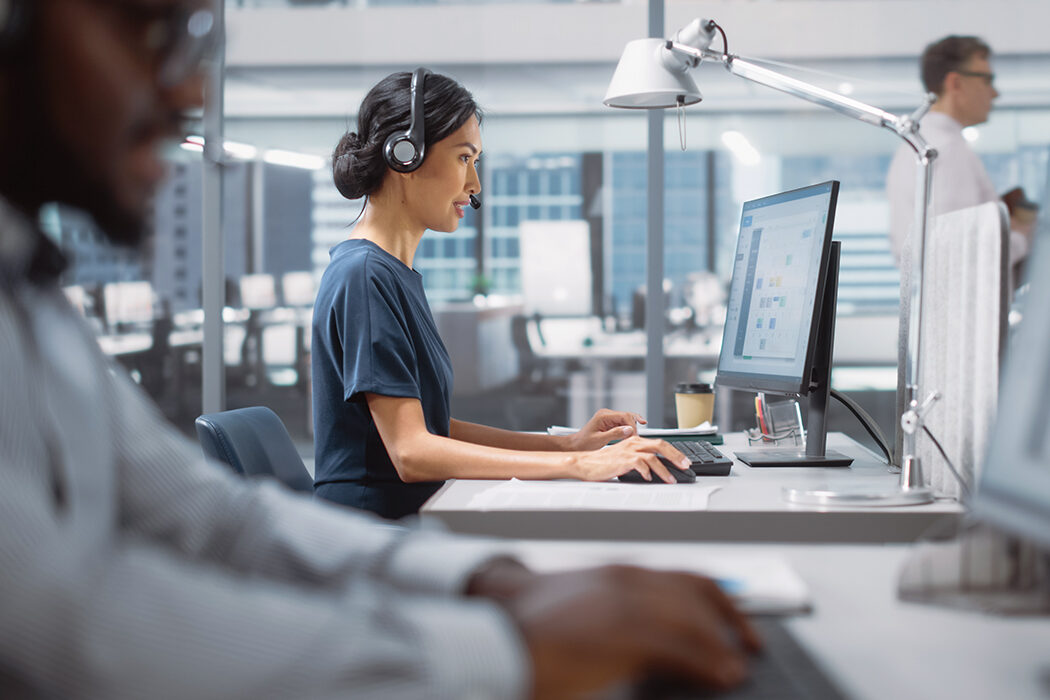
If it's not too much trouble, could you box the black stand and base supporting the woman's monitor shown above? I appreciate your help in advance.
[734,240,853,467]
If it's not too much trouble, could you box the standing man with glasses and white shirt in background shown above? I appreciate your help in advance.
[886,36,1028,264]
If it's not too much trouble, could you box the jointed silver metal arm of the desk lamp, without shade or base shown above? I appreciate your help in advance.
[665,40,949,490]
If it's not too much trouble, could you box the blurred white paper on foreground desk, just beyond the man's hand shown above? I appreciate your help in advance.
[517,543,813,615]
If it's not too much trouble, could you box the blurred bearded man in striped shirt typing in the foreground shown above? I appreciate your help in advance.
[0,0,758,700]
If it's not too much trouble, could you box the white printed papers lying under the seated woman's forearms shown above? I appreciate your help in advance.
[469,479,719,511]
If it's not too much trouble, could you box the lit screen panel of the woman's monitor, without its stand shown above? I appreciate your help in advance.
[716,181,839,395]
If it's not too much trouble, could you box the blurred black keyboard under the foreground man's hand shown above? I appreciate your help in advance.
[621,617,846,700]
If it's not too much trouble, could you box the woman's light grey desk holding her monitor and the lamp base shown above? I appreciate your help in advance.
[421,433,963,543]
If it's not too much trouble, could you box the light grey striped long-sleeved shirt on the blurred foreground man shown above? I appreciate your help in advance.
[0,200,527,700]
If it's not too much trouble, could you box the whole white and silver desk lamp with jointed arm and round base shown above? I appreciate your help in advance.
[604,19,940,506]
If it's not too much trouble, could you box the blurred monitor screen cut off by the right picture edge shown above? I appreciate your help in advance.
[973,240,1050,551]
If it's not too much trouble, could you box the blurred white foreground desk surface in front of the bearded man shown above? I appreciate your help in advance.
[508,540,1050,700]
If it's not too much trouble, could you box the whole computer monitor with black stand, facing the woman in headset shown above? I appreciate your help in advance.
[715,181,853,467]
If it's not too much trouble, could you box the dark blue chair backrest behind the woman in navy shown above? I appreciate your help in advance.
[196,406,314,492]
